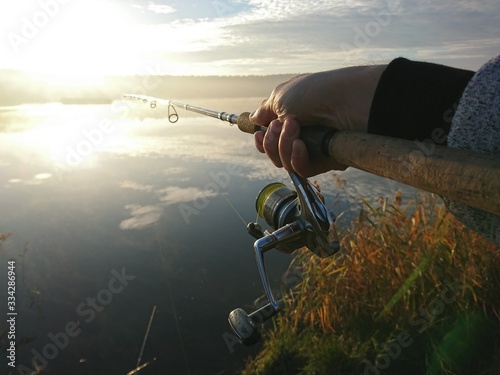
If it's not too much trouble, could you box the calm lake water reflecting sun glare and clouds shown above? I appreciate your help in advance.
[0,98,411,374]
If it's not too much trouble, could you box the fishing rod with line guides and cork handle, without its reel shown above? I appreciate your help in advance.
[126,95,500,215]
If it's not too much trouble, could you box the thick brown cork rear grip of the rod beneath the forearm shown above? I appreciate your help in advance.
[329,131,500,215]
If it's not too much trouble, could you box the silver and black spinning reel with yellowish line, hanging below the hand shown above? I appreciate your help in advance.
[228,172,340,345]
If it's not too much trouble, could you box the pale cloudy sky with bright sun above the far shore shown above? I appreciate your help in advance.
[0,0,500,76]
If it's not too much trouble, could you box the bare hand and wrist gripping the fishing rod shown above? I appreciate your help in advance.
[250,65,385,177]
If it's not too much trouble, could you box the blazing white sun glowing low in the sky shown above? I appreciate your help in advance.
[22,0,135,77]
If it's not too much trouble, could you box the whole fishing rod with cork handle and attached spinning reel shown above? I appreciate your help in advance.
[124,94,500,345]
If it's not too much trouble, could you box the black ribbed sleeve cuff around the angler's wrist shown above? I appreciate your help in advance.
[368,57,474,144]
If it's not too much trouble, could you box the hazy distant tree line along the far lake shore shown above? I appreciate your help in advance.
[0,70,293,106]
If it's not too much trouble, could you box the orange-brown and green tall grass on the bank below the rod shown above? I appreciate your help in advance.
[244,194,500,375]
